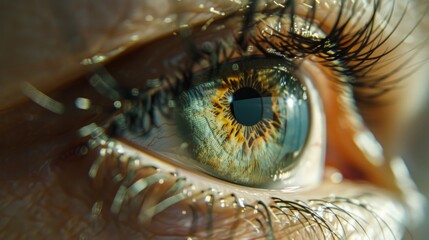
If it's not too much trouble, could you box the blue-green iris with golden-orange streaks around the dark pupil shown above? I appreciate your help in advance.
[177,59,310,186]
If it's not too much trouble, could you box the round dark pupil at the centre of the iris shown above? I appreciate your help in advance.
[230,87,263,126]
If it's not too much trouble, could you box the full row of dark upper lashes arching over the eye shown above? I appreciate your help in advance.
[100,0,414,136]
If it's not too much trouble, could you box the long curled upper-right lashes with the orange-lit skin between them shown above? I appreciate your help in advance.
[253,0,426,101]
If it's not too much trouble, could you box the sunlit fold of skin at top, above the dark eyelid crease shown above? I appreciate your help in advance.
[77,0,240,53]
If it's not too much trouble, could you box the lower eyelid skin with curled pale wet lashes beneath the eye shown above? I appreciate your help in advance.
[81,125,398,239]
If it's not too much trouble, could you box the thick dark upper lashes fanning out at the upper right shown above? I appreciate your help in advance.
[253,0,424,94]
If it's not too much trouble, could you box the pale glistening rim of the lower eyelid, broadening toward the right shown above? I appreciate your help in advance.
[91,137,412,239]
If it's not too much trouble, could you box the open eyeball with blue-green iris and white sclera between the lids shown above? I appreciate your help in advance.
[103,10,325,188]
